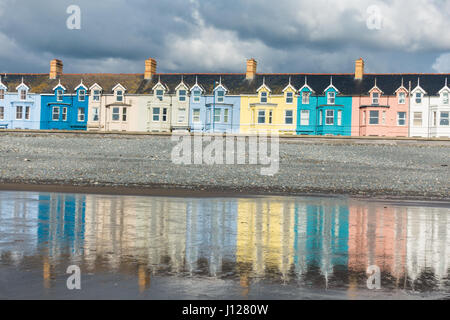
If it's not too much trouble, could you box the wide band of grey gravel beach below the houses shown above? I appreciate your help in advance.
[0,133,450,200]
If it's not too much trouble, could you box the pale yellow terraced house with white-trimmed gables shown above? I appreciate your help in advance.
[240,77,297,134]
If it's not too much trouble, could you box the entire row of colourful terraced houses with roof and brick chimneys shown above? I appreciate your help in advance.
[0,58,450,137]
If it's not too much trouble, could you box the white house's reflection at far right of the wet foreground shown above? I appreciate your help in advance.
[406,207,450,289]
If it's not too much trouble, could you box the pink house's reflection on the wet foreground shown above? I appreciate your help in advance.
[348,202,408,281]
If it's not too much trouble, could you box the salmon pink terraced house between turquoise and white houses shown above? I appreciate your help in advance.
[352,79,409,137]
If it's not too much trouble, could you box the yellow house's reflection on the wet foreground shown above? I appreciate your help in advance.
[236,198,295,279]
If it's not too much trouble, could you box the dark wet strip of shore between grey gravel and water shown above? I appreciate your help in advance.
[0,181,450,208]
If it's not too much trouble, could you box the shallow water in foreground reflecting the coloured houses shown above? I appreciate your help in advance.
[0,192,450,299]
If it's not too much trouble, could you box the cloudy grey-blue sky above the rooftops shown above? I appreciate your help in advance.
[0,0,450,73]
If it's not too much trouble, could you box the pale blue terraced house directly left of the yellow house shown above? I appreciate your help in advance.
[189,77,241,133]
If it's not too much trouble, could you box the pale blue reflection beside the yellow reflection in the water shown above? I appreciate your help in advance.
[186,199,237,276]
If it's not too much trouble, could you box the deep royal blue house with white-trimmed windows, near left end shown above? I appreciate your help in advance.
[41,81,89,130]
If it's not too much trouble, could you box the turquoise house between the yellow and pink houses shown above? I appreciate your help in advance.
[297,78,352,136]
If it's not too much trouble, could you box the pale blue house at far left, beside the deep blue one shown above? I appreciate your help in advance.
[0,78,41,130]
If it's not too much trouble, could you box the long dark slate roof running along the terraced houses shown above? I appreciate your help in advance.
[1,73,450,96]
